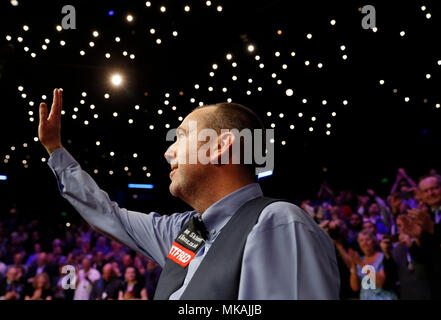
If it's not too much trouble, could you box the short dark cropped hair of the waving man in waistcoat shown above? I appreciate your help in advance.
[193,102,266,178]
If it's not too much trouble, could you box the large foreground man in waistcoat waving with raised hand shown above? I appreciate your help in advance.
[39,90,340,299]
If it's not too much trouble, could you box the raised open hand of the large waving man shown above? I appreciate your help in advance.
[38,89,63,155]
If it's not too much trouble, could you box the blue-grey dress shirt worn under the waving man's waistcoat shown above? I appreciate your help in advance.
[48,148,340,300]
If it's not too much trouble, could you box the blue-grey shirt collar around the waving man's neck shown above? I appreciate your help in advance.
[202,183,263,240]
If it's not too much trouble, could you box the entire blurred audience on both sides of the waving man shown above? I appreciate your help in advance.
[0,168,441,300]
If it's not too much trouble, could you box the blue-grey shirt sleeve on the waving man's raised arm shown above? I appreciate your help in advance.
[48,148,197,266]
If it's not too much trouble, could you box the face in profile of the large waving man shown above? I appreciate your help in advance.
[164,107,215,198]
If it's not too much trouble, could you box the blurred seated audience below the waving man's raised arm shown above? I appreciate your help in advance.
[0,218,161,300]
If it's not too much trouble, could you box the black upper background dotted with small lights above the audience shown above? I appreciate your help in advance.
[0,0,441,225]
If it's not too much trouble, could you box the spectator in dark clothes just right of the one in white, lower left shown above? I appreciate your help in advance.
[89,263,121,300]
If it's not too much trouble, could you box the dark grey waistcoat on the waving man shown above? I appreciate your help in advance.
[154,197,281,300]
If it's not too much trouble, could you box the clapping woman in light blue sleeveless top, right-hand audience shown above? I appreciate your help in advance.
[349,230,397,300]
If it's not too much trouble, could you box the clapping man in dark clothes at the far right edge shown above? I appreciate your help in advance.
[404,174,441,299]
